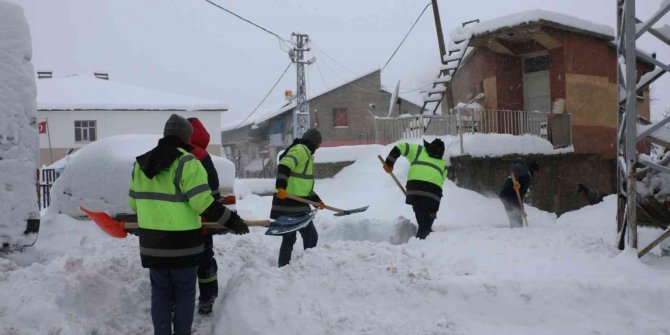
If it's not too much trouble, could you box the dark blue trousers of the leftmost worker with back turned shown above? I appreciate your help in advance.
[149,266,197,335]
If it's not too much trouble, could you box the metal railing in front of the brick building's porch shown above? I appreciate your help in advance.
[375,108,549,144]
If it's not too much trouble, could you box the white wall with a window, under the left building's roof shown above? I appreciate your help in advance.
[38,110,221,149]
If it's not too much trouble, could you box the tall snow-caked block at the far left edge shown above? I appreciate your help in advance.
[0,0,40,251]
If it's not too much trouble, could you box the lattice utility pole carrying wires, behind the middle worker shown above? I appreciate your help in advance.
[288,33,316,138]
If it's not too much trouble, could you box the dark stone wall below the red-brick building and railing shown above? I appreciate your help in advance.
[449,154,616,215]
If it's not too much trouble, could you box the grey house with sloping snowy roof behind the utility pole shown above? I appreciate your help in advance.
[221,69,421,177]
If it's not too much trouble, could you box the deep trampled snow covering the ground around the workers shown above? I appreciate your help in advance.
[0,144,670,335]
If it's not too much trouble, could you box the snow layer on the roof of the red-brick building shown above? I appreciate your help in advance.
[468,9,614,39]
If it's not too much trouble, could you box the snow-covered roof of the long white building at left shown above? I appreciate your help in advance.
[37,75,229,111]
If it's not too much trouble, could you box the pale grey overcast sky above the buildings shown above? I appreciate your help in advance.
[11,0,670,124]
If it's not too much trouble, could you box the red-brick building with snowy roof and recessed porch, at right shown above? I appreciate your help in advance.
[443,10,654,158]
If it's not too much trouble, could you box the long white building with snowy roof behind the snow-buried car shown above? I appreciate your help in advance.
[37,72,228,165]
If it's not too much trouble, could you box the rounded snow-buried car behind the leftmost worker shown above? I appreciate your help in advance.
[48,135,235,217]
